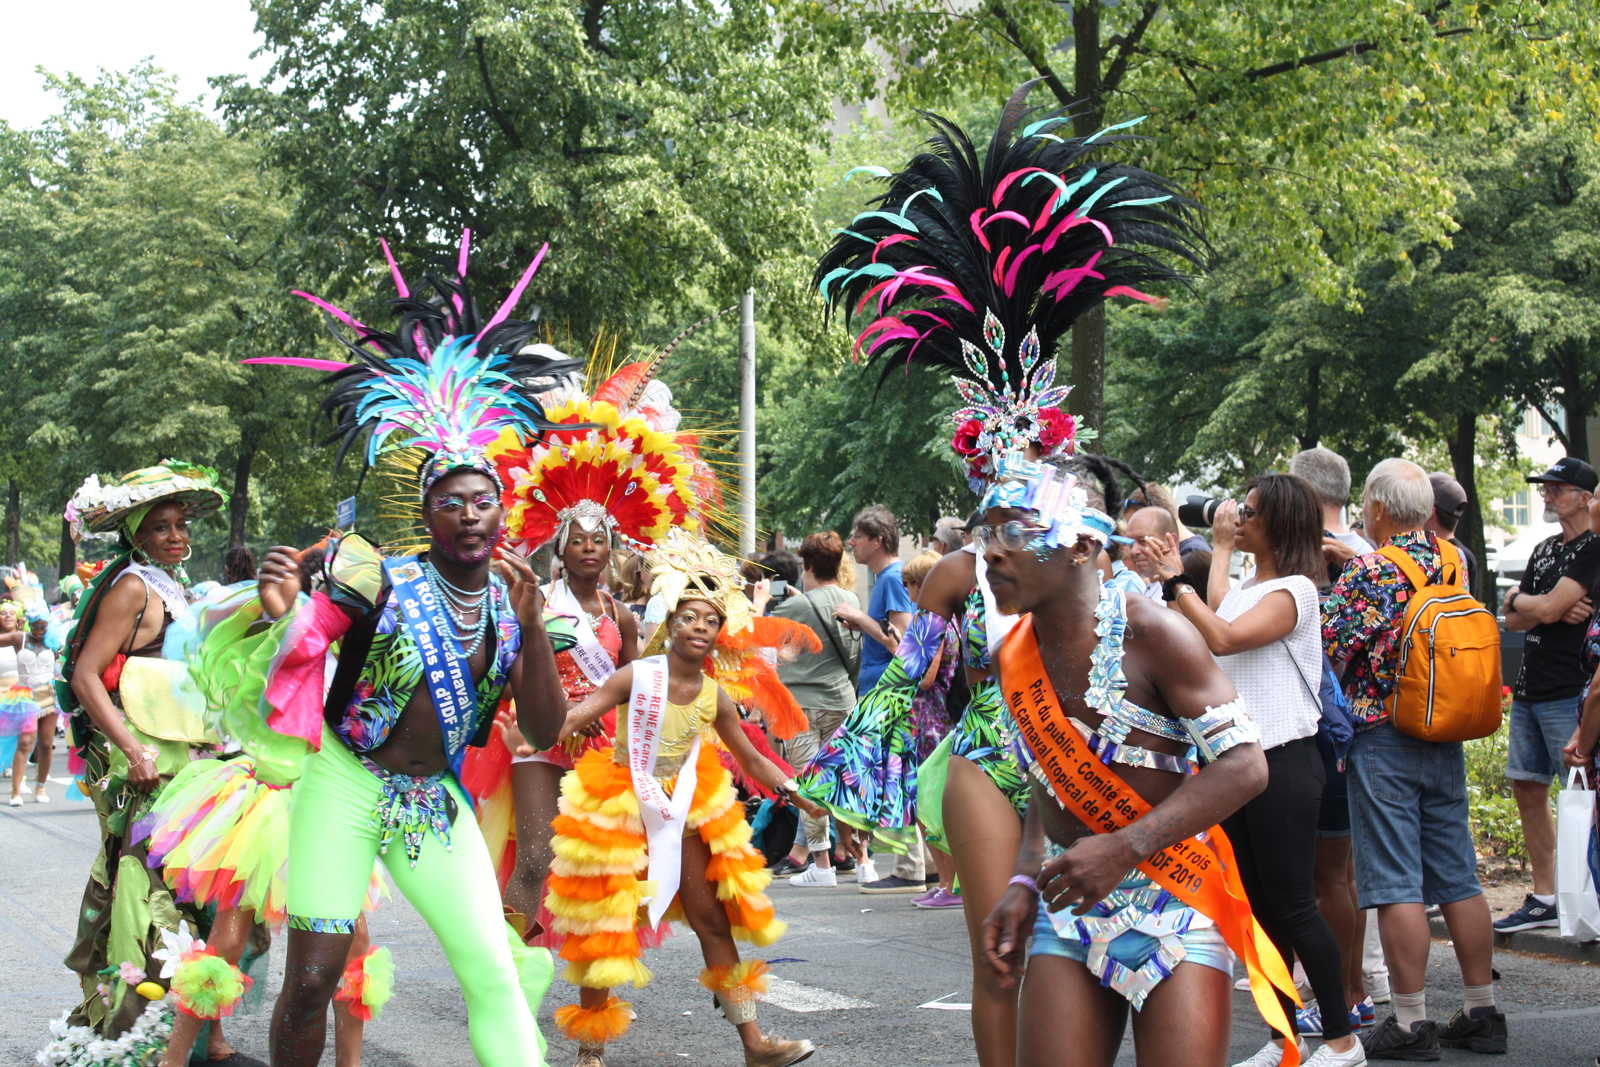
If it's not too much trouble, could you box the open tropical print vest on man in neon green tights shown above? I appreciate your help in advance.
[333,576,524,752]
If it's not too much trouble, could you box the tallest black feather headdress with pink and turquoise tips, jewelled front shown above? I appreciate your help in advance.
[816,82,1203,493]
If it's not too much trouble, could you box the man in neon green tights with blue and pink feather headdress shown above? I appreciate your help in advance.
[259,238,592,1067]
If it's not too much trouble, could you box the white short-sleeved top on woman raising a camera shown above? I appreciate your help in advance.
[1216,574,1322,749]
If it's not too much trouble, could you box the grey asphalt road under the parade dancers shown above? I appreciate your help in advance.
[0,748,1600,1067]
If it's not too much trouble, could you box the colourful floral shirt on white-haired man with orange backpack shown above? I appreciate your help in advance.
[1322,530,1440,729]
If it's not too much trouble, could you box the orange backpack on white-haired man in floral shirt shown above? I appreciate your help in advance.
[1378,539,1501,741]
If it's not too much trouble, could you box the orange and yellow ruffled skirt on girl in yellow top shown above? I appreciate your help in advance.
[544,742,784,1038]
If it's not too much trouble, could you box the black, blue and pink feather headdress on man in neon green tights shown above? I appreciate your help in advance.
[245,230,581,496]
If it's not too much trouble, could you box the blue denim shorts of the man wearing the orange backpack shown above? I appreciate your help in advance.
[1347,721,1482,909]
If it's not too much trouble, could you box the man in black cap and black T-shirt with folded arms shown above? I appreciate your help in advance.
[1494,456,1600,934]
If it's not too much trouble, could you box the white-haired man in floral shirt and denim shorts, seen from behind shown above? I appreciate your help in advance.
[1323,459,1506,1059]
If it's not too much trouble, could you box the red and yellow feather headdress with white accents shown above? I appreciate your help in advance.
[490,312,736,552]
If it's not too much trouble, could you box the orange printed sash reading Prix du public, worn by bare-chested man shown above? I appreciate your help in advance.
[1000,616,1299,1067]
